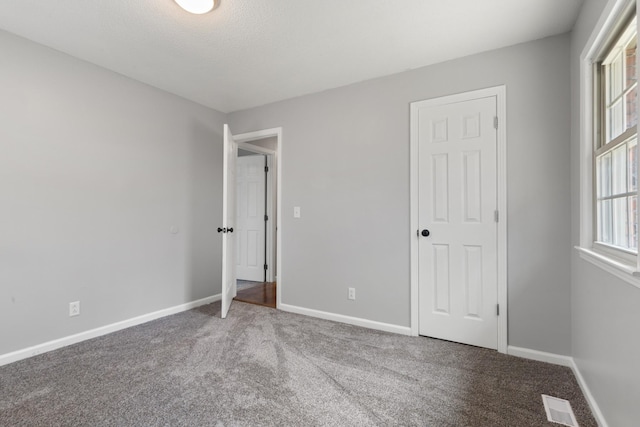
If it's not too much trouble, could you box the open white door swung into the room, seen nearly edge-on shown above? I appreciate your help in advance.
[218,124,238,319]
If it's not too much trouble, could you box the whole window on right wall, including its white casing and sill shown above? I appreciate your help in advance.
[576,0,640,289]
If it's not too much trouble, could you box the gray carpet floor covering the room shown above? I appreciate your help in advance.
[0,302,596,427]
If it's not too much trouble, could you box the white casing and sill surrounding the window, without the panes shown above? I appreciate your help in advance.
[576,0,640,288]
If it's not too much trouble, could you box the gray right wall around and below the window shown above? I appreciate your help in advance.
[571,0,640,427]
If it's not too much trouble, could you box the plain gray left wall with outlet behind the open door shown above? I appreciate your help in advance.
[0,32,225,354]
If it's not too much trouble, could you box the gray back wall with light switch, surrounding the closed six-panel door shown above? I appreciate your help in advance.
[229,35,571,354]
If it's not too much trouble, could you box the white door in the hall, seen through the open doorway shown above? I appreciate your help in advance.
[236,155,266,282]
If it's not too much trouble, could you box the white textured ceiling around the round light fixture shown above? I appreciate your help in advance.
[0,0,582,112]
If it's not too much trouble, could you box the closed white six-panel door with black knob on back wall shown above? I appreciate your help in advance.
[412,96,498,349]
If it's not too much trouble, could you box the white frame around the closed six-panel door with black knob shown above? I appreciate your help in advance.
[409,86,508,353]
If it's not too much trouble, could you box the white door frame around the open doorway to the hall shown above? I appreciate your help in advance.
[234,127,283,309]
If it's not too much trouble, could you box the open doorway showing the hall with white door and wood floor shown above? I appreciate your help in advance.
[234,131,279,308]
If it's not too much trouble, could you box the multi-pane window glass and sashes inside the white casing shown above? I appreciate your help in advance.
[593,15,638,255]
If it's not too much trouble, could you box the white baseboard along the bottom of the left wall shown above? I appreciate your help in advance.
[0,294,222,366]
